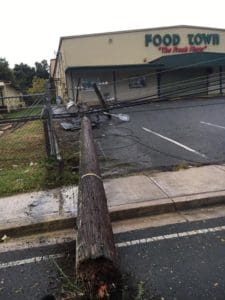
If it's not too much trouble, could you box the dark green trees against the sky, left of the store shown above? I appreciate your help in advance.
[0,58,49,94]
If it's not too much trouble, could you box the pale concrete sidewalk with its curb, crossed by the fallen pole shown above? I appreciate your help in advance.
[0,165,225,237]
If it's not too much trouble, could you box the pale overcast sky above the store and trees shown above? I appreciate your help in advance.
[0,0,225,68]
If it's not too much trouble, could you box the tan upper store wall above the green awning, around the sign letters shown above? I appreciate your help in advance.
[59,26,225,69]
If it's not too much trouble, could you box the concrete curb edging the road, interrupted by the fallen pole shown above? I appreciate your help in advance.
[0,191,225,238]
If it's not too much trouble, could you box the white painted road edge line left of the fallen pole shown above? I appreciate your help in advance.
[0,253,65,270]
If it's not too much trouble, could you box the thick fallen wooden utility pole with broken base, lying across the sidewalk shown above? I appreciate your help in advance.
[76,116,120,299]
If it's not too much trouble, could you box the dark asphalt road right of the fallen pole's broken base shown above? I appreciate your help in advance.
[116,218,225,300]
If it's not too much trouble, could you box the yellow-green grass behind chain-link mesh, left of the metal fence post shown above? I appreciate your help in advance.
[0,120,46,196]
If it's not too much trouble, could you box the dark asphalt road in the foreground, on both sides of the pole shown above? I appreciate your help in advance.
[0,217,225,300]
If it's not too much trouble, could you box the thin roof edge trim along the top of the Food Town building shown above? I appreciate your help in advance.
[53,25,225,77]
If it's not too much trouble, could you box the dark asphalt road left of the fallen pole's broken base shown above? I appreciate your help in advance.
[0,243,75,300]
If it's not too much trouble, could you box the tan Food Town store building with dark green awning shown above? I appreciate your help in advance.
[52,26,225,105]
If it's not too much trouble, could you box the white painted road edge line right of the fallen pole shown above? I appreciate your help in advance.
[116,226,225,248]
